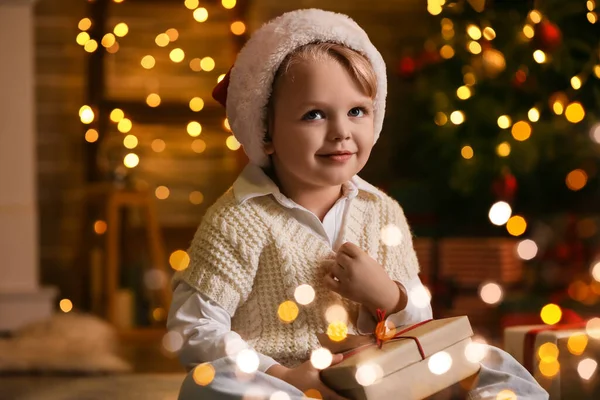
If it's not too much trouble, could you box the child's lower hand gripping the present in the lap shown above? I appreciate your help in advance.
[267,354,348,400]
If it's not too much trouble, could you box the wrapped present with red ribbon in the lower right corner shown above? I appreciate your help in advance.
[504,322,600,400]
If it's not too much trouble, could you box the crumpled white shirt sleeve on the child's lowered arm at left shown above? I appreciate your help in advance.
[167,281,278,372]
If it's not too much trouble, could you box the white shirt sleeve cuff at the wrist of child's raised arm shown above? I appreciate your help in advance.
[357,276,433,334]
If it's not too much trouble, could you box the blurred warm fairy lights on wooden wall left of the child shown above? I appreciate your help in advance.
[76,0,241,205]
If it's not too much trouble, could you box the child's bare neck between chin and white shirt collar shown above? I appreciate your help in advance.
[266,169,342,222]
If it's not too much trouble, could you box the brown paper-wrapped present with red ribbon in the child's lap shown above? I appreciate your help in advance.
[321,316,480,400]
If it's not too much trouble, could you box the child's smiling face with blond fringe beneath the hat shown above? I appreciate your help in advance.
[265,58,374,191]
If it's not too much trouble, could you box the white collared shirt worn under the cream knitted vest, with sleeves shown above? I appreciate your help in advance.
[167,164,432,372]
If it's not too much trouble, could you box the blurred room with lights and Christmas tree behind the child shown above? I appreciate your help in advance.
[0,0,600,396]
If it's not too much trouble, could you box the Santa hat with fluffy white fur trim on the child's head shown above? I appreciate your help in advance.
[213,9,387,167]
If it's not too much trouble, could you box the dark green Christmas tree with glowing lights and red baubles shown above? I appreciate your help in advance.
[398,0,600,241]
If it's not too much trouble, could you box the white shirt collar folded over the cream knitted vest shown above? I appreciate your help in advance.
[233,164,381,208]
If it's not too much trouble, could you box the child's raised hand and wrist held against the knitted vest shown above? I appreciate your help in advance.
[323,242,406,315]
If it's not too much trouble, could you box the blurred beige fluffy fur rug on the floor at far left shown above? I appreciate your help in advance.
[0,313,131,374]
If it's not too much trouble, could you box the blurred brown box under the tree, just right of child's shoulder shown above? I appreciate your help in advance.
[439,238,523,287]
